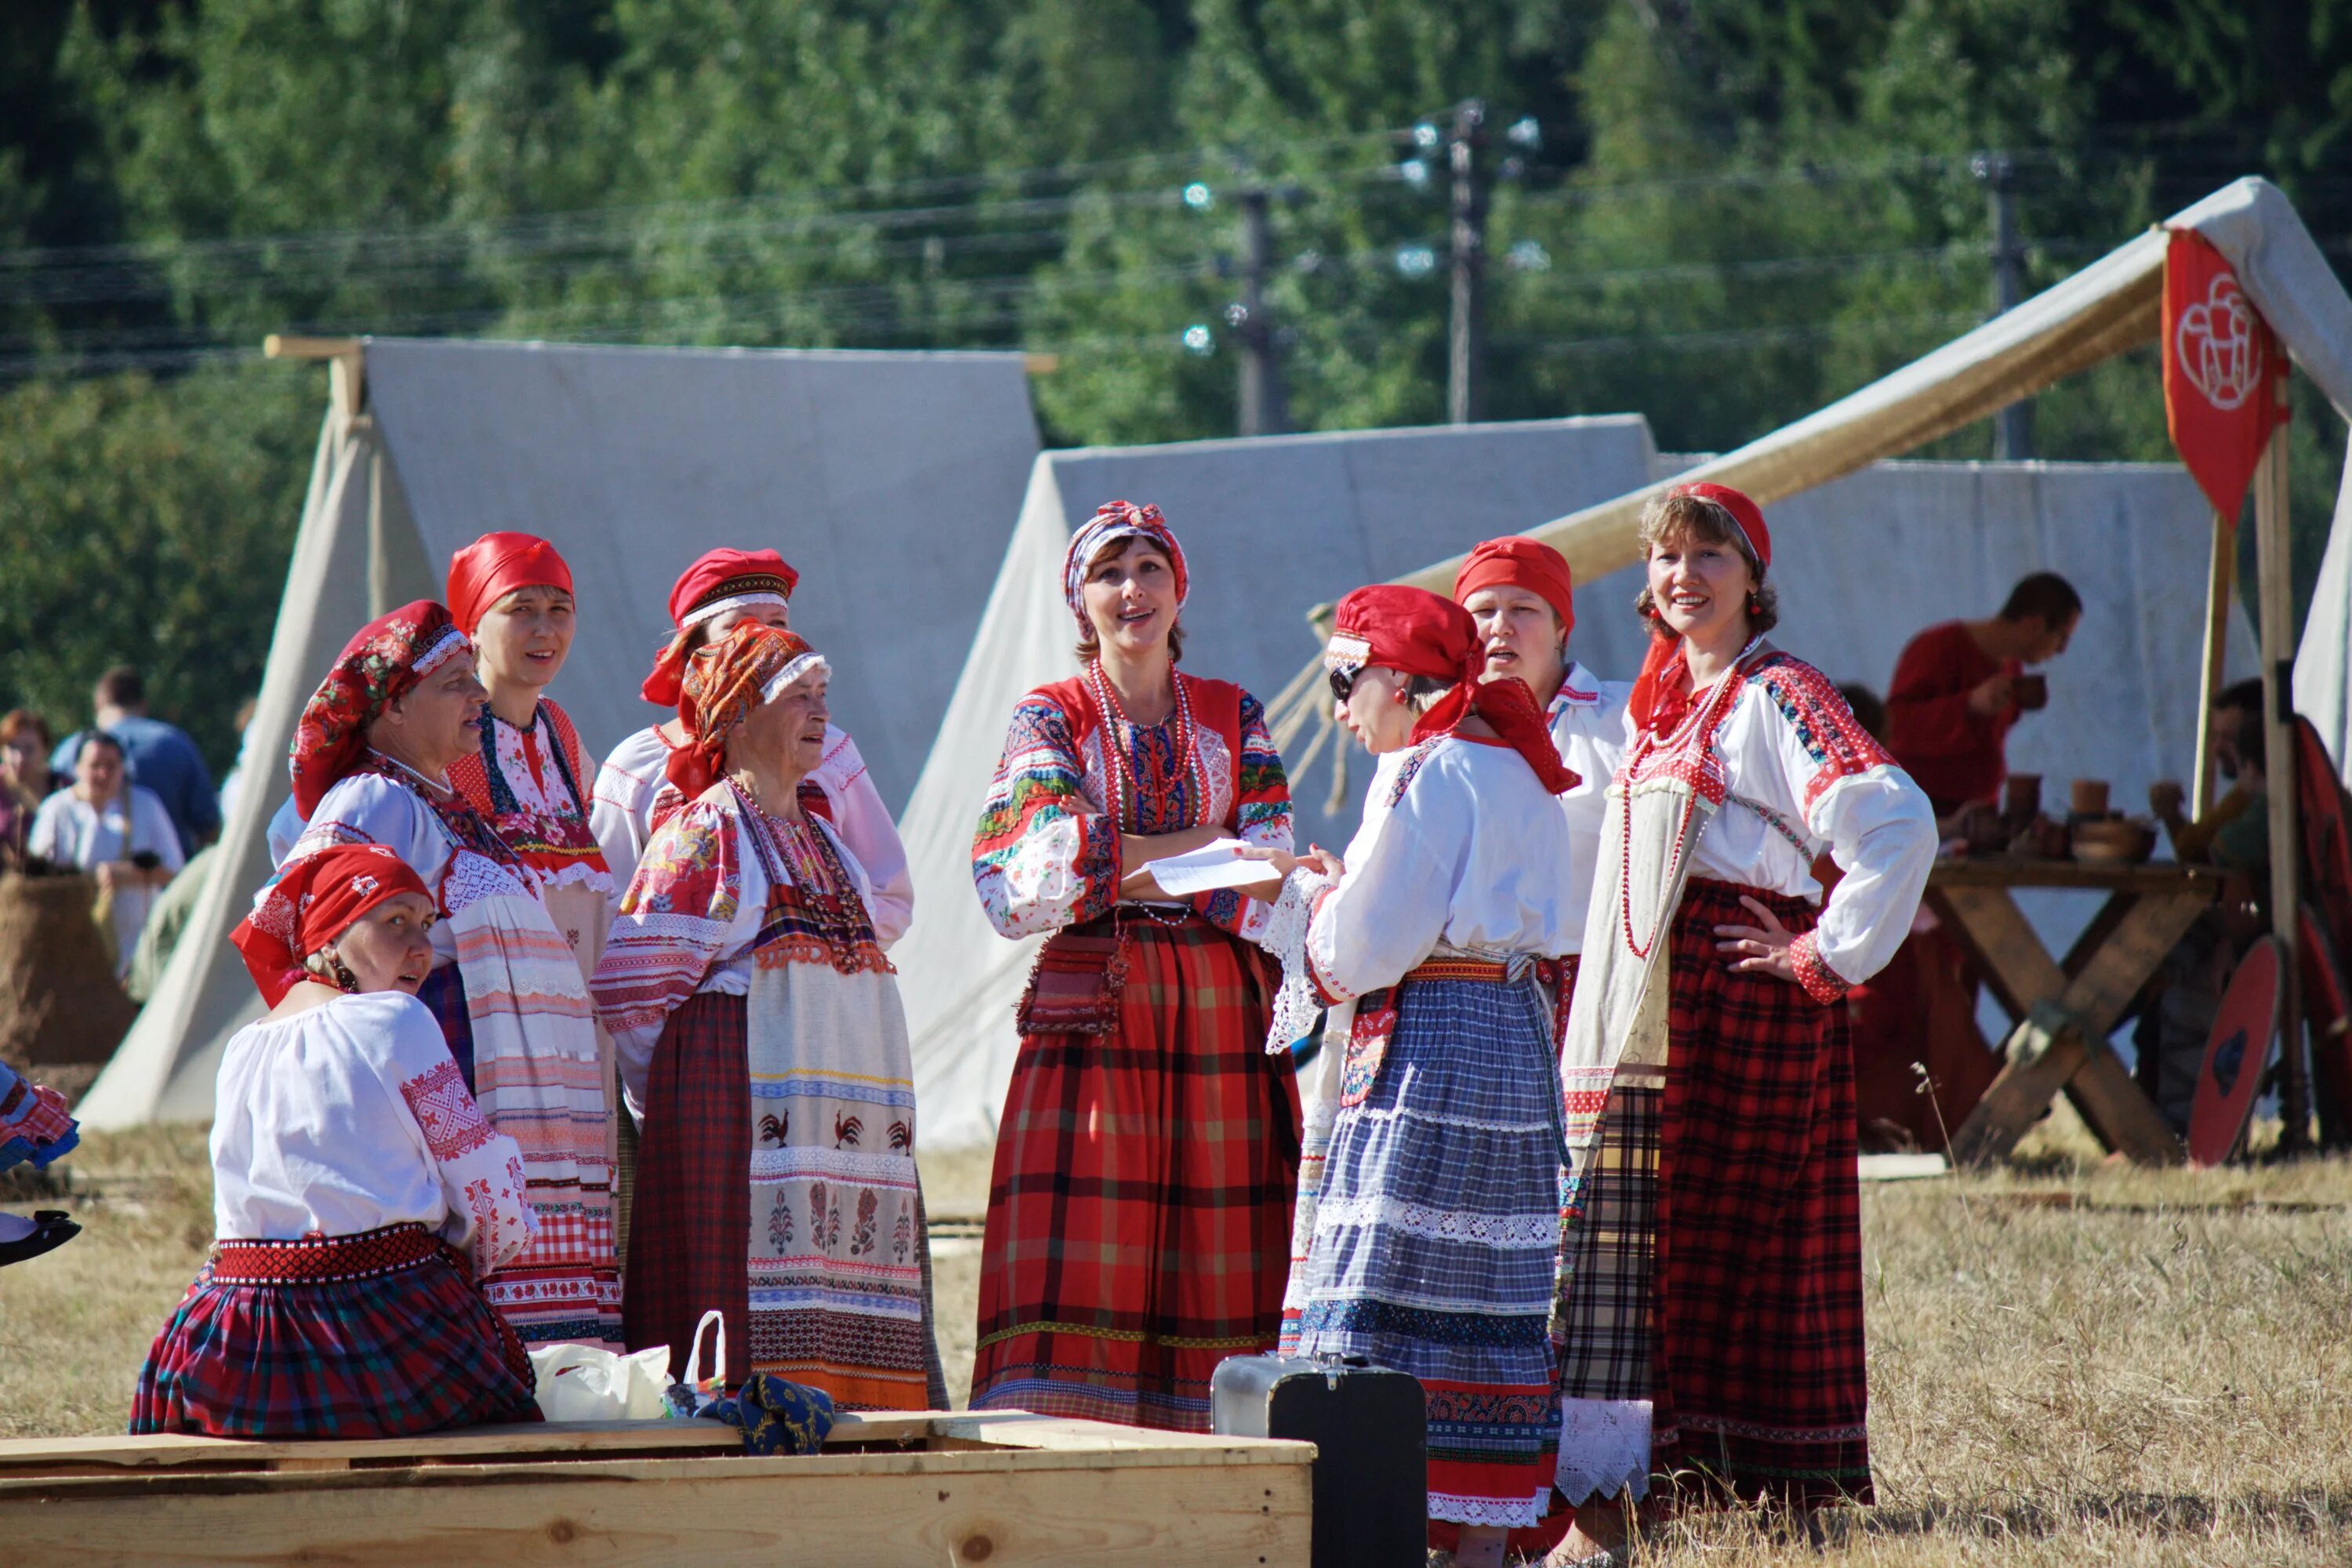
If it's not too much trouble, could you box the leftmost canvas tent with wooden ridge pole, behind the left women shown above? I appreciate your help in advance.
[80,339,1037,1126]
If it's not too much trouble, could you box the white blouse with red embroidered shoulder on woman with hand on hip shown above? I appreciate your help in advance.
[1646,656,1936,989]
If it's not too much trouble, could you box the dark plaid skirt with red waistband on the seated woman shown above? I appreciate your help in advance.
[129,1225,539,1439]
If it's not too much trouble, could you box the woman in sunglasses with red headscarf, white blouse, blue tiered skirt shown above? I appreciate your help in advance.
[1268,586,1581,1563]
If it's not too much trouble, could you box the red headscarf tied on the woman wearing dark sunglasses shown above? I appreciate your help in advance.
[1324,583,1578,794]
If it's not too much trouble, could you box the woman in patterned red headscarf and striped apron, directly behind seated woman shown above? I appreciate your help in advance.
[280,600,621,1347]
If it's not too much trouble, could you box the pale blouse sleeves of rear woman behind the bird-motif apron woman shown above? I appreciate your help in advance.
[588,724,915,949]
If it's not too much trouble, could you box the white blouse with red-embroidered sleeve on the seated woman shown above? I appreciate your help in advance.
[212,992,539,1276]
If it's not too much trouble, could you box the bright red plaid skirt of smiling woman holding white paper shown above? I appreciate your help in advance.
[971,919,1298,1432]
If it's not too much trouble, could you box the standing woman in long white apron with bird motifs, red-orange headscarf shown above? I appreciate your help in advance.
[595,623,946,1410]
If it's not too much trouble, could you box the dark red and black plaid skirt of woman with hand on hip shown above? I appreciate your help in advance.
[1651,879,1870,1504]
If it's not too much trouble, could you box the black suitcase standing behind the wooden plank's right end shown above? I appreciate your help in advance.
[1209,1356,1430,1568]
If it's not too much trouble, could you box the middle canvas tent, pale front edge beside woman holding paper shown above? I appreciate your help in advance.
[891,416,1653,1147]
